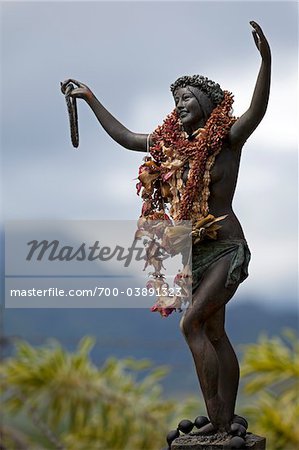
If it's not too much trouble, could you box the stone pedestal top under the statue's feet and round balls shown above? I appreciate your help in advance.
[170,433,266,450]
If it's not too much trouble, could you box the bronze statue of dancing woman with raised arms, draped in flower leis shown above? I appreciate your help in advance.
[62,22,271,442]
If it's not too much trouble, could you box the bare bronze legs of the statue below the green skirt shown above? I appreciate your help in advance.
[181,255,238,430]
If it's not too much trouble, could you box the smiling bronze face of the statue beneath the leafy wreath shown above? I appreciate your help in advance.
[173,86,204,133]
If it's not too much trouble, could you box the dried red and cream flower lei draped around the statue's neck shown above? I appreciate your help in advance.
[136,91,236,316]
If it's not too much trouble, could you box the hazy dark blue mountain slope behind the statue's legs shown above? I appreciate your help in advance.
[4,299,297,393]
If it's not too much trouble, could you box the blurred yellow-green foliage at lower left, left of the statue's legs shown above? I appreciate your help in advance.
[0,337,200,450]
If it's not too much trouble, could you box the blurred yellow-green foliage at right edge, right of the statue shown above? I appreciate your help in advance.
[242,330,299,450]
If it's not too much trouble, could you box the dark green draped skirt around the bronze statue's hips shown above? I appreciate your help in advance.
[192,239,250,293]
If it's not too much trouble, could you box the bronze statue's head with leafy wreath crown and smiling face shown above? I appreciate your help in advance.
[170,75,224,134]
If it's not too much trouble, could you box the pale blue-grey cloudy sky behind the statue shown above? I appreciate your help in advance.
[1,1,298,306]
